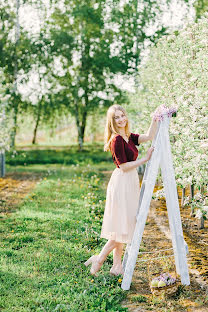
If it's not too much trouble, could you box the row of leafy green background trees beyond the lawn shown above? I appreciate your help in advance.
[0,0,198,149]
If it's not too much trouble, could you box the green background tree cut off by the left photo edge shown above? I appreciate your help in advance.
[0,0,38,146]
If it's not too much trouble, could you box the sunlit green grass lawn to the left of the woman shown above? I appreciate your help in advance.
[0,161,127,312]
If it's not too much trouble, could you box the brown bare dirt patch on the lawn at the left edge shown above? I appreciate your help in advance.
[0,172,40,213]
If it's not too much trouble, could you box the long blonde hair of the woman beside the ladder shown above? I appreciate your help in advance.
[104,104,130,152]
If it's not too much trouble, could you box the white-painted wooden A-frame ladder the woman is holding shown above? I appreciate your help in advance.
[121,114,190,290]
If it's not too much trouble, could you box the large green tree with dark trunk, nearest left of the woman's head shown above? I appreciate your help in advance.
[49,0,125,148]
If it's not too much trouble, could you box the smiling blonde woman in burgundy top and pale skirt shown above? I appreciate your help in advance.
[84,105,157,275]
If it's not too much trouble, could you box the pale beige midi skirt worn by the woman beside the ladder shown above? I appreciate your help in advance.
[100,168,140,244]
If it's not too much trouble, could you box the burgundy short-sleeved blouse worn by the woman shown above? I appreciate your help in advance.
[111,133,139,168]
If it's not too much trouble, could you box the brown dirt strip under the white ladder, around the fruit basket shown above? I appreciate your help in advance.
[123,201,208,312]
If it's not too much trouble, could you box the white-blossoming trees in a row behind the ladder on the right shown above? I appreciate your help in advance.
[131,14,208,224]
